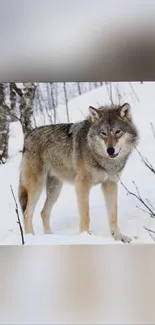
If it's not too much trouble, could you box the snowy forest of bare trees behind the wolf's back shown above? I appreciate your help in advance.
[0,82,136,164]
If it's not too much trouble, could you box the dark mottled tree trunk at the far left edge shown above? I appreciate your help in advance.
[0,83,9,163]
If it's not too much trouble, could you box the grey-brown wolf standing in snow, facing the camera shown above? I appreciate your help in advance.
[19,103,139,243]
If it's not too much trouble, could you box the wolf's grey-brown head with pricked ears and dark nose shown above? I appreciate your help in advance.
[88,103,138,159]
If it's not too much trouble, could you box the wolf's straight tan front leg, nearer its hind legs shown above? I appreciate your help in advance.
[75,173,90,233]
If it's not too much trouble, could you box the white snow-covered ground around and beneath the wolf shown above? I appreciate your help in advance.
[0,82,155,245]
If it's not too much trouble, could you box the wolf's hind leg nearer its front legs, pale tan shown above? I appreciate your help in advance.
[41,175,63,234]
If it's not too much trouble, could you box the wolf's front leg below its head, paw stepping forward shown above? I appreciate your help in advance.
[102,182,131,243]
